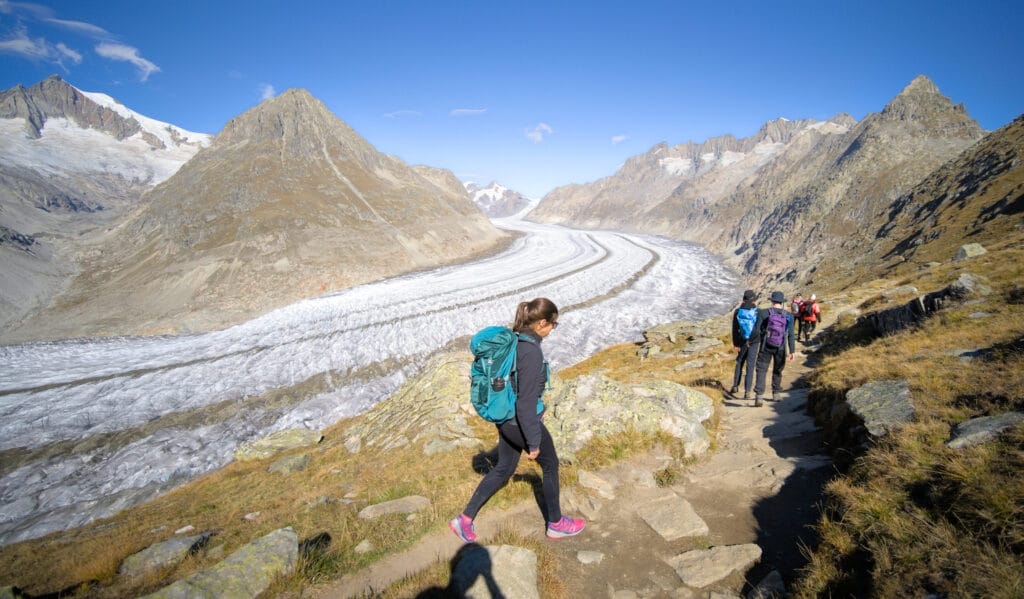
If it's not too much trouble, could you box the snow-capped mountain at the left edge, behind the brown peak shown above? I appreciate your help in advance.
[0,76,213,327]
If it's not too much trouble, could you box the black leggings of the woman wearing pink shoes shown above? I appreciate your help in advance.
[463,420,562,522]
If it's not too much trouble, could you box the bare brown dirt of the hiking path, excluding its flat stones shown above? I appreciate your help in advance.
[315,348,831,598]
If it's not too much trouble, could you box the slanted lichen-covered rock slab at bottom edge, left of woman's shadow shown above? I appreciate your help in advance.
[146,527,299,599]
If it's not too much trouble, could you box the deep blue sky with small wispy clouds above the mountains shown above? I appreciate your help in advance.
[0,0,1024,198]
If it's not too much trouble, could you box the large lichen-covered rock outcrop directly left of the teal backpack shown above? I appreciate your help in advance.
[344,351,481,454]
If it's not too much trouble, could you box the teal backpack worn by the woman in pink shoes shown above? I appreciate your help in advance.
[469,327,544,424]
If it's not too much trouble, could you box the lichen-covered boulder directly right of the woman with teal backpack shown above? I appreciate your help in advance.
[545,375,713,461]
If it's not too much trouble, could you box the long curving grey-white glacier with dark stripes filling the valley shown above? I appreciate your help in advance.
[0,217,738,544]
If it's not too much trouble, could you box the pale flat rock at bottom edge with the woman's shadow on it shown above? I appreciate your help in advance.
[451,545,541,599]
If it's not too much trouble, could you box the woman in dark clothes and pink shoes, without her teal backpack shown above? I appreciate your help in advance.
[449,297,586,543]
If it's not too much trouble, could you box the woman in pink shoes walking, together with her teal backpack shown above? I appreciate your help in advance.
[449,297,586,543]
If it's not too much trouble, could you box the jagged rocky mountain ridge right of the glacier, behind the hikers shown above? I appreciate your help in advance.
[530,76,984,285]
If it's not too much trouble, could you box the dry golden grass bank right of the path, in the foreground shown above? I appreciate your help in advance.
[796,244,1024,597]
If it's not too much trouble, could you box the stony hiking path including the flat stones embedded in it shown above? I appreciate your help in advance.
[315,341,831,599]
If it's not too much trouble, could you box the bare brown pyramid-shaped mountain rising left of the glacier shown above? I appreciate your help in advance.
[3,89,504,337]
